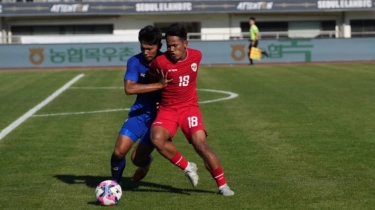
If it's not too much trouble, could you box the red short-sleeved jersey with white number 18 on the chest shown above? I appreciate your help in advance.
[150,48,202,106]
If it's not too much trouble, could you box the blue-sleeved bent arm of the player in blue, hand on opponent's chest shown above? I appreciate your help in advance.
[124,56,170,95]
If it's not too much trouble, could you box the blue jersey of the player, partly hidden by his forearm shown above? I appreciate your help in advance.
[124,53,161,117]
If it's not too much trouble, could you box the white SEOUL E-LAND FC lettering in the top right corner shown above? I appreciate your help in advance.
[318,0,372,9]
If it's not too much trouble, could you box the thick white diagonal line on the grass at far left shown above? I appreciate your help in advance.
[0,74,85,140]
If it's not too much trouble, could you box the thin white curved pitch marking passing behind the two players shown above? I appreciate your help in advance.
[32,87,238,117]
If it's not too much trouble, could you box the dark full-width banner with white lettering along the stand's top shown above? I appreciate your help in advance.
[0,0,375,17]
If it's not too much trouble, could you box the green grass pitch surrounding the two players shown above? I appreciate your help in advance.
[0,64,375,210]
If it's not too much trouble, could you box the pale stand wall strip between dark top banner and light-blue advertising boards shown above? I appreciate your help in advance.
[5,11,375,42]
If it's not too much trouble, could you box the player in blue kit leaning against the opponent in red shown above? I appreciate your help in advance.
[111,26,170,183]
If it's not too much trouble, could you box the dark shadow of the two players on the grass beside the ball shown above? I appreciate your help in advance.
[54,174,216,195]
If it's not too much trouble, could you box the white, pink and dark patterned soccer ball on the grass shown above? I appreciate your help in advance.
[95,180,122,206]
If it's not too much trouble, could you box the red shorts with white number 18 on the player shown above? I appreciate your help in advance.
[151,105,207,142]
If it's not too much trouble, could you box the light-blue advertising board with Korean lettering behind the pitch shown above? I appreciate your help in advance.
[0,38,375,69]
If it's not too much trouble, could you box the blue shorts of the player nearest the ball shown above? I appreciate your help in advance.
[119,114,154,149]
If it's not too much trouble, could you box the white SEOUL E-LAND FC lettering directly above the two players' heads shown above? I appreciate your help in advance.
[135,2,193,12]
